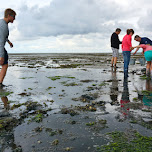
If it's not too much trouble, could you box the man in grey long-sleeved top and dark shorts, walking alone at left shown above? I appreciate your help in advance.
[0,8,16,88]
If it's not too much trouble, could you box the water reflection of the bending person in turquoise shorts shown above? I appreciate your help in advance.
[142,80,152,107]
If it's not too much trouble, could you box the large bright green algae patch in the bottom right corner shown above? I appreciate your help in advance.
[97,131,152,152]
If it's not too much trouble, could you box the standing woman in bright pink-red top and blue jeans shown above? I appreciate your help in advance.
[122,29,134,78]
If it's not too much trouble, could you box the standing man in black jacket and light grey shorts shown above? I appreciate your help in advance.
[111,28,122,68]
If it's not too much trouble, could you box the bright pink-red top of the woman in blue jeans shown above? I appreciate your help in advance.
[122,34,132,51]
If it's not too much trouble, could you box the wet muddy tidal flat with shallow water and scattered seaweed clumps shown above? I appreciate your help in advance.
[0,54,152,152]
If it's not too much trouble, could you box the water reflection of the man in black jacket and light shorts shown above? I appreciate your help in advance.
[110,68,118,105]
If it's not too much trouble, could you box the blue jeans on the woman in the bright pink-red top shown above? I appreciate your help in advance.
[123,51,130,77]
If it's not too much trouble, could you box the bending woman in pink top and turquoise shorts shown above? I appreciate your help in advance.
[131,44,152,78]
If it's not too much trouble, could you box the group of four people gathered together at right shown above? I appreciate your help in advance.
[111,28,152,78]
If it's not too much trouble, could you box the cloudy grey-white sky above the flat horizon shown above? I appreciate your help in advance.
[0,0,152,53]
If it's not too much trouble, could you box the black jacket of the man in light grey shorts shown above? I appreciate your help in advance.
[111,32,122,49]
